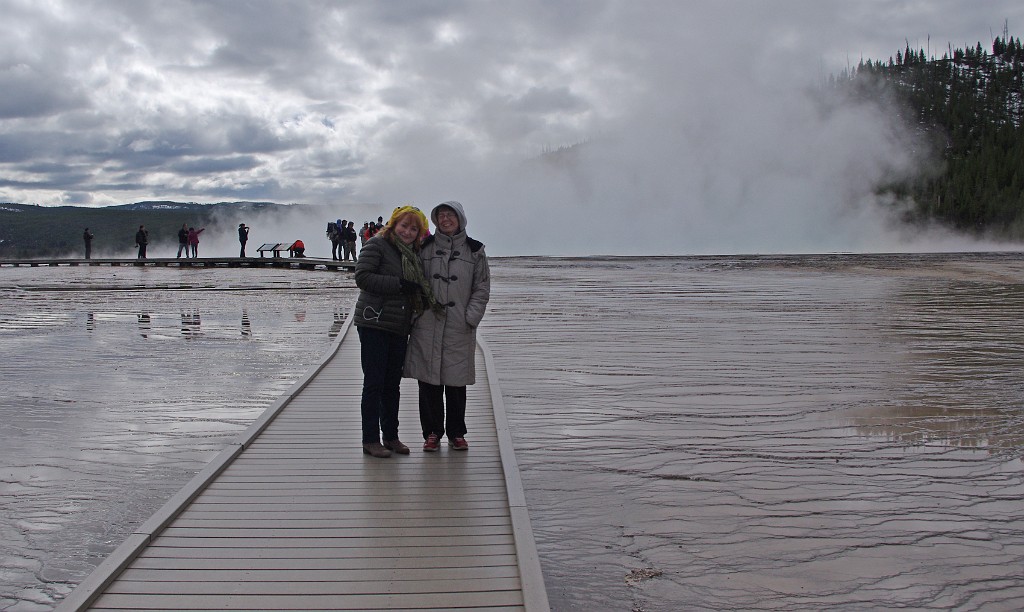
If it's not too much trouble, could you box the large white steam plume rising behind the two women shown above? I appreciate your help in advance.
[342,5,1005,255]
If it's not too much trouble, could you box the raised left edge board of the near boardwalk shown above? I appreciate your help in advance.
[54,312,352,612]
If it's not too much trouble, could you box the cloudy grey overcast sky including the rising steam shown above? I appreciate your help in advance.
[0,0,1024,254]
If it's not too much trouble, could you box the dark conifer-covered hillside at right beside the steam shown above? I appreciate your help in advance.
[833,35,1024,239]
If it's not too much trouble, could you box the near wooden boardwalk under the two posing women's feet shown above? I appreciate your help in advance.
[57,317,549,611]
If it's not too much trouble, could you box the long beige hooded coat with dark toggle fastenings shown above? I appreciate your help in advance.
[403,203,490,387]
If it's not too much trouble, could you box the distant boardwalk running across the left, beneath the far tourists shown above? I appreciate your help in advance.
[0,257,355,271]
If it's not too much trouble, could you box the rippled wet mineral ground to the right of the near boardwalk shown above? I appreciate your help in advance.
[483,255,1024,611]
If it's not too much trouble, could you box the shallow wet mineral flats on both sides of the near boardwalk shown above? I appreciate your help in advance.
[0,254,1024,611]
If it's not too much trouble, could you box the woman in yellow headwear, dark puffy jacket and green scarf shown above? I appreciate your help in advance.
[352,206,438,457]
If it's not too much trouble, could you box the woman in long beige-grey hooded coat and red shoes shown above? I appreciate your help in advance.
[403,202,490,452]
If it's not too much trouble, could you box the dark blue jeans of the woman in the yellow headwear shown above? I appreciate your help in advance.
[355,327,409,444]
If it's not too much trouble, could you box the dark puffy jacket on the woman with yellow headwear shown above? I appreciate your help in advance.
[352,236,413,336]
